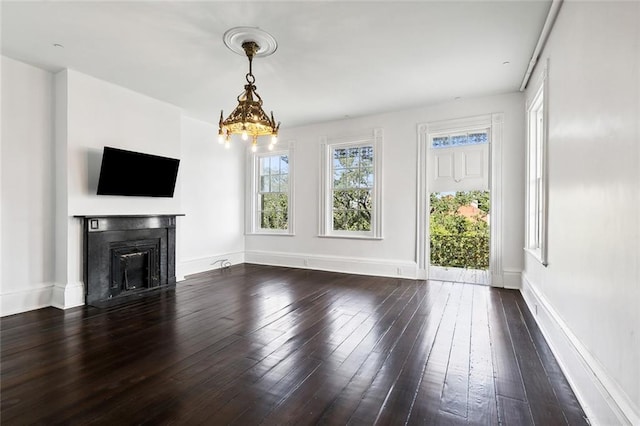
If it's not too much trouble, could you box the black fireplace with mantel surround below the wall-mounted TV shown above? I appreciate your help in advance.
[83,215,176,307]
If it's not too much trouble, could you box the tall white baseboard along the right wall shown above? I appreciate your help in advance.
[520,273,640,425]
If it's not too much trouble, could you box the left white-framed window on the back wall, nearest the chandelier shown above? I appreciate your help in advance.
[249,147,293,234]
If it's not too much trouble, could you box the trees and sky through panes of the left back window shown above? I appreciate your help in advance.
[258,155,289,230]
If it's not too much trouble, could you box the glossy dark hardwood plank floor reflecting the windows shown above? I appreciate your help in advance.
[0,265,587,425]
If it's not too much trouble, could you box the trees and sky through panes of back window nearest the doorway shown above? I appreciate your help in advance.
[332,145,373,231]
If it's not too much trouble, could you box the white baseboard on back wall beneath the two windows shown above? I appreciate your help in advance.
[245,251,418,279]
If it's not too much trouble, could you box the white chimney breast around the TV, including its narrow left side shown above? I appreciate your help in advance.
[52,70,181,308]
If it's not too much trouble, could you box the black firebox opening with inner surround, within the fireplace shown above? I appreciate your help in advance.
[109,240,160,297]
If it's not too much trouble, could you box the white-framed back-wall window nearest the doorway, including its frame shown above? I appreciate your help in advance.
[320,130,382,238]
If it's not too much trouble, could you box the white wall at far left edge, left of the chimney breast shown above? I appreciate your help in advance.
[0,57,54,315]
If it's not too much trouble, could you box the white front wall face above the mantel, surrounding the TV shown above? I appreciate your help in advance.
[63,70,181,215]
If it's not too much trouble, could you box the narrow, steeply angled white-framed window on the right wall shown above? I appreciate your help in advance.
[527,76,547,264]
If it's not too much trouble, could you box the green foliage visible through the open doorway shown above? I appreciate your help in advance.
[429,191,491,269]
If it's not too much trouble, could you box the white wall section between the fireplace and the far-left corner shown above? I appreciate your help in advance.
[176,117,244,276]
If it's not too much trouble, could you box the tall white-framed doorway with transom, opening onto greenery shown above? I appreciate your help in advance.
[416,113,504,287]
